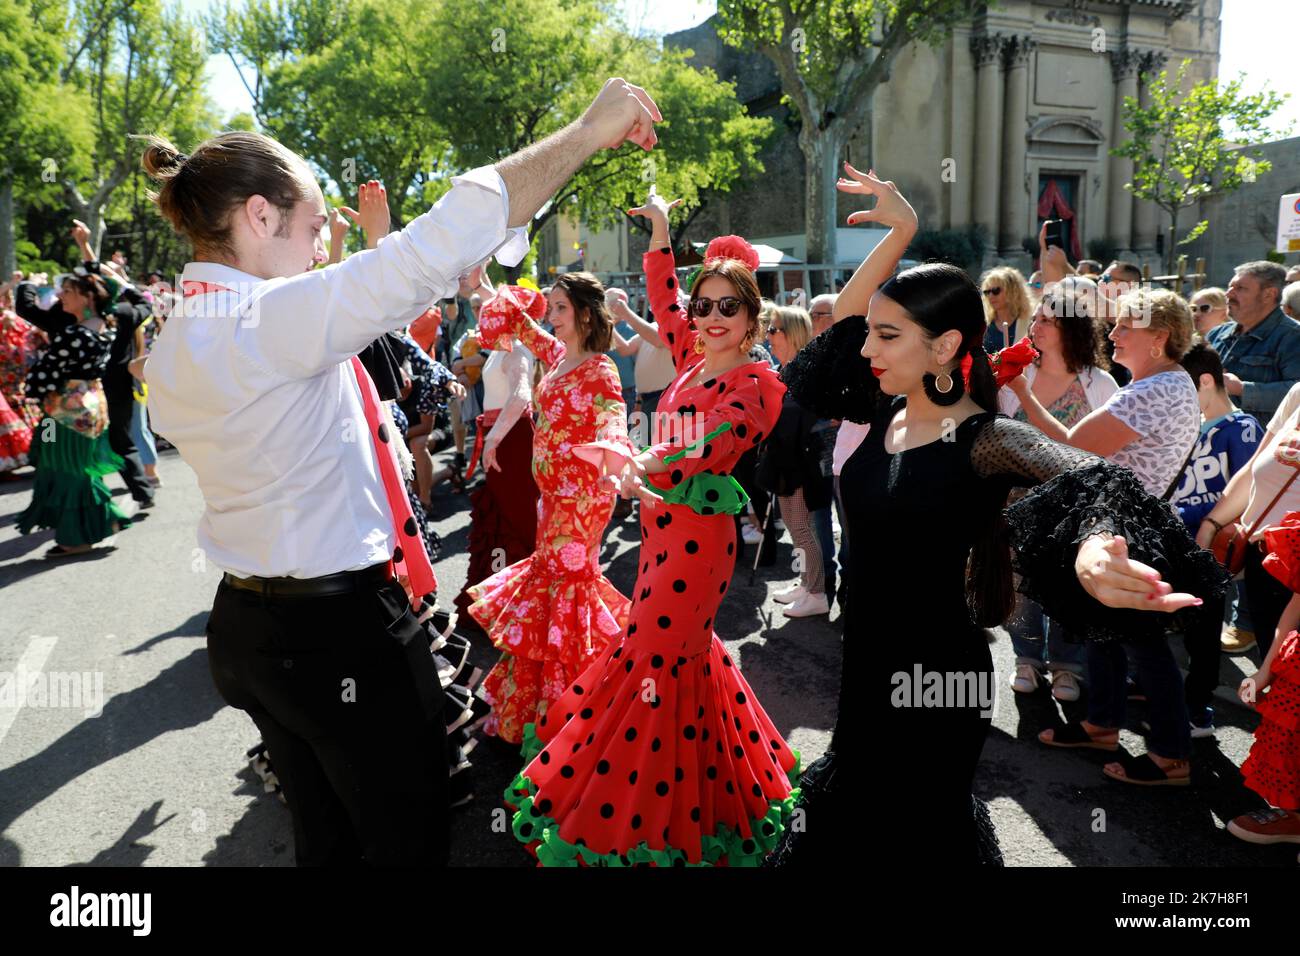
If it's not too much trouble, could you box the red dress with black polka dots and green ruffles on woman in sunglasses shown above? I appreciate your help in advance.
[506,250,800,866]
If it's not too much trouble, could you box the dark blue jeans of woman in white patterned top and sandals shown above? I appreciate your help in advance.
[1087,640,1192,760]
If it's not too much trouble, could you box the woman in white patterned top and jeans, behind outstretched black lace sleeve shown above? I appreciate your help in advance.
[1010,289,1201,786]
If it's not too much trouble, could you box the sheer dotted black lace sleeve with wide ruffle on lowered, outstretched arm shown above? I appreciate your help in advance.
[971,418,1230,640]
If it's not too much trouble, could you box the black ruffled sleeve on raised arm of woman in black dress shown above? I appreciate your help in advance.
[781,315,889,425]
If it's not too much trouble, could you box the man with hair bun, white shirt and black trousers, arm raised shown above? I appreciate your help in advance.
[142,78,662,866]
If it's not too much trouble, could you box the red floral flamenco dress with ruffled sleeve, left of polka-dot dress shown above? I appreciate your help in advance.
[468,286,631,744]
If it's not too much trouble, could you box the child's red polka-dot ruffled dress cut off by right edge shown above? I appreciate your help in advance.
[1242,511,1300,810]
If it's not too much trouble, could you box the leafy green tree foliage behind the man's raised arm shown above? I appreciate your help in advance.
[208,0,771,273]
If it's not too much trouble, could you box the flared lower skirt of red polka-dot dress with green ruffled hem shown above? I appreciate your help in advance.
[506,640,800,866]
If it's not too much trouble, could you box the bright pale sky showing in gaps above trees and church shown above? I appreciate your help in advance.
[181,0,1300,135]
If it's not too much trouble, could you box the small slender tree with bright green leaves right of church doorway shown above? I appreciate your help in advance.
[1110,60,1290,273]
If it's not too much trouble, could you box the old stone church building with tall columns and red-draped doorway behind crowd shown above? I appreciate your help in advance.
[540,0,1242,283]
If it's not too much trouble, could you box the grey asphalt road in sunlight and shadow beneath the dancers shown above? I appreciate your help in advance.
[0,453,1296,866]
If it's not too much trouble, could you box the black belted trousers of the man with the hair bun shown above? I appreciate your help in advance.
[208,581,449,866]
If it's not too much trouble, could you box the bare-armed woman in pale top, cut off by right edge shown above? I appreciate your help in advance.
[1196,382,1300,659]
